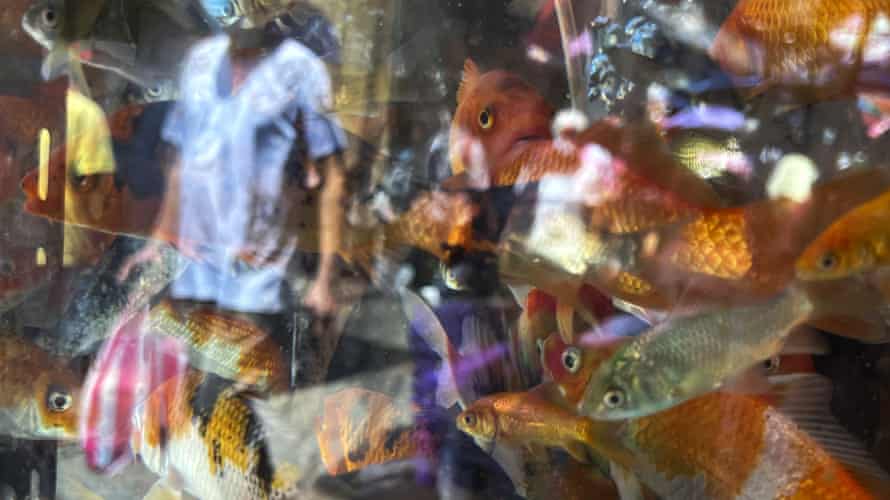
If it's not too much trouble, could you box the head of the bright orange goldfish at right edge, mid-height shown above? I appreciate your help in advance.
[794,228,860,280]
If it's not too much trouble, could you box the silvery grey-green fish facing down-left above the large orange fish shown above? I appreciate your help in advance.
[580,289,813,420]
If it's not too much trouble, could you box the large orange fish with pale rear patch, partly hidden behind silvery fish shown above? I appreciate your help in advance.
[544,336,875,499]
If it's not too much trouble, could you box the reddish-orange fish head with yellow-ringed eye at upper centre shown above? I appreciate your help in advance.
[449,59,555,174]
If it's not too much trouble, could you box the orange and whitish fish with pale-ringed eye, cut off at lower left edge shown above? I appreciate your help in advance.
[0,332,82,439]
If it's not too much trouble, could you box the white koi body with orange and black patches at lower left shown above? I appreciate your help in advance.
[131,372,298,500]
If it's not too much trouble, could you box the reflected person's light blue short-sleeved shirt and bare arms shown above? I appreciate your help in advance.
[130,36,345,315]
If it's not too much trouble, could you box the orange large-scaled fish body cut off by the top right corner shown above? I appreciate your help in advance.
[708,0,890,100]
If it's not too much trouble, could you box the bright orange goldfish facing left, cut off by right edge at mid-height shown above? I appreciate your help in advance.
[795,186,890,280]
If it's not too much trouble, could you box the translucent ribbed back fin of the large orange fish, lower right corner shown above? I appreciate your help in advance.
[770,373,890,496]
